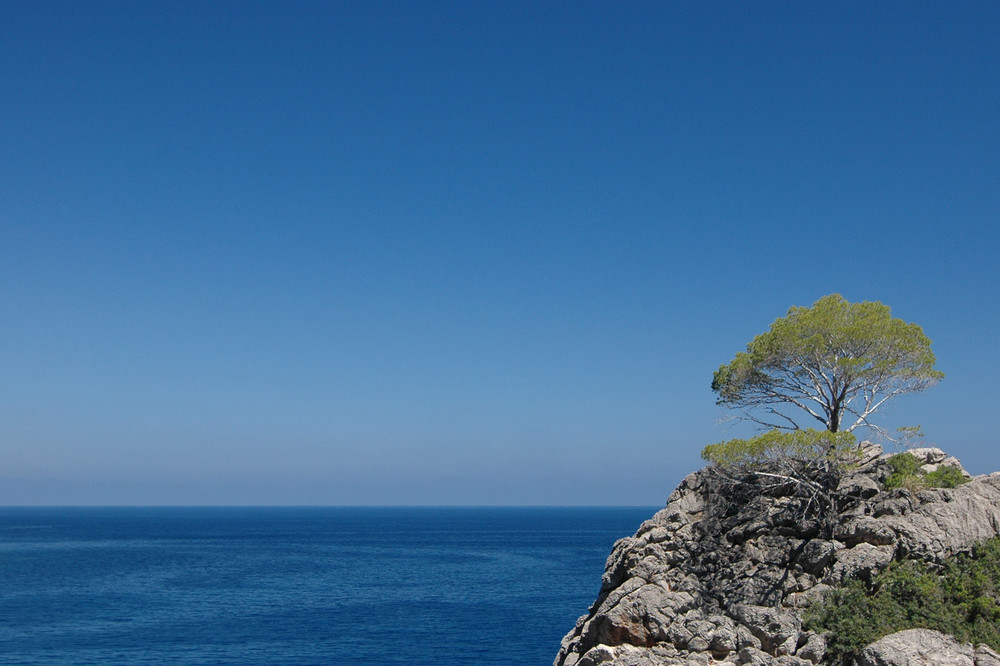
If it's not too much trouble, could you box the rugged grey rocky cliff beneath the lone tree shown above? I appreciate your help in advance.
[555,445,1000,666]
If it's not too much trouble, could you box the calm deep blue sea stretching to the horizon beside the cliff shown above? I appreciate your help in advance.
[0,507,654,666]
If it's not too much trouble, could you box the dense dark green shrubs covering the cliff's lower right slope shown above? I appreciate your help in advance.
[805,536,1000,663]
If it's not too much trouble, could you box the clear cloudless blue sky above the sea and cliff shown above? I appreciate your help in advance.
[0,0,1000,506]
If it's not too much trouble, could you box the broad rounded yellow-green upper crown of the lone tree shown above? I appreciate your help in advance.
[712,294,944,432]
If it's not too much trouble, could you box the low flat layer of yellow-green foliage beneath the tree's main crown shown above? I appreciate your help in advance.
[701,428,856,470]
